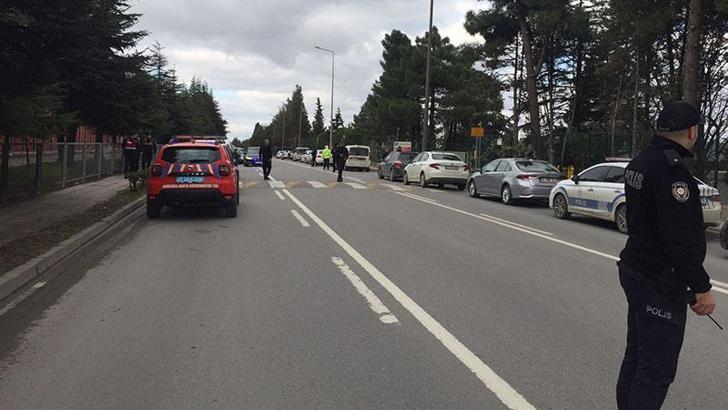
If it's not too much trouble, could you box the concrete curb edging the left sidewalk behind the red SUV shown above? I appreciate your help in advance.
[0,197,145,300]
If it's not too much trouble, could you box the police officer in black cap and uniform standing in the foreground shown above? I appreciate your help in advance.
[617,101,715,409]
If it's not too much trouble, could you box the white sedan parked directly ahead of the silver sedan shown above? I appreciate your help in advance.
[404,151,470,190]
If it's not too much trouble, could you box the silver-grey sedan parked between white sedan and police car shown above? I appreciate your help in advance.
[468,158,563,205]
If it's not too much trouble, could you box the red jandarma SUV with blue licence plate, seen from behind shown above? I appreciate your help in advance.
[147,140,240,218]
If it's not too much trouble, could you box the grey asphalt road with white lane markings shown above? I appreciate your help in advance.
[0,161,728,409]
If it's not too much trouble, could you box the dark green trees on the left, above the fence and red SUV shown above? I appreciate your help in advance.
[0,0,226,146]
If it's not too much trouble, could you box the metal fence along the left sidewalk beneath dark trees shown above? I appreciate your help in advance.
[0,142,123,200]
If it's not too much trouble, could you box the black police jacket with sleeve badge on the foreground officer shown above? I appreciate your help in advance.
[620,137,711,293]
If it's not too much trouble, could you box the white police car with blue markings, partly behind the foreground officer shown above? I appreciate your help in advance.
[549,161,722,233]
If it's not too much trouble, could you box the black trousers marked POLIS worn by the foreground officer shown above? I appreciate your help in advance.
[617,264,687,410]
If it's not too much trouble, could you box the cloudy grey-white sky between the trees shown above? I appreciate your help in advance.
[130,0,486,138]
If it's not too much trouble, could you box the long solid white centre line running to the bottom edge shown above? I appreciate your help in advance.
[283,190,535,410]
